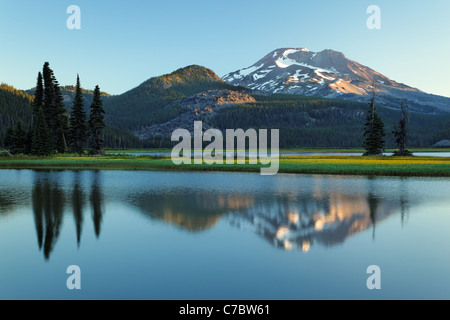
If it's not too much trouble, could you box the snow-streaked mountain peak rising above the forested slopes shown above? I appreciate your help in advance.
[222,48,450,112]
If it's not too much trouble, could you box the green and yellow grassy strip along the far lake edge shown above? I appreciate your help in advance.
[0,155,450,177]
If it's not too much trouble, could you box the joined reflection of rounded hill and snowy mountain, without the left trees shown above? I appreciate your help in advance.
[129,178,410,252]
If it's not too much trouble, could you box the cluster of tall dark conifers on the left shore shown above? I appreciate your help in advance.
[4,62,105,156]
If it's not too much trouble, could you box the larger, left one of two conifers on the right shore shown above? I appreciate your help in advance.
[364,92,386,156]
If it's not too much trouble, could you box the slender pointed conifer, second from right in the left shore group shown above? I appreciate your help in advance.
[70,75,87,154]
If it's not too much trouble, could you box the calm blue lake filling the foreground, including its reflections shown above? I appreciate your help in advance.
[0,170,450,300]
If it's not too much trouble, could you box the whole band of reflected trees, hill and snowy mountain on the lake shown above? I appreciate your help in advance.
[0,171,412,259]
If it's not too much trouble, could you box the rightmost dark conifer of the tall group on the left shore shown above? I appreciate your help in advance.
[89,86,105,154]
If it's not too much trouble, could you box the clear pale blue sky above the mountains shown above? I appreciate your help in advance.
[0,0,450,97]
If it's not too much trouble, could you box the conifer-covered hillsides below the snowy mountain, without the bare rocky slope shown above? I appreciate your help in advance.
[4,65,450,148]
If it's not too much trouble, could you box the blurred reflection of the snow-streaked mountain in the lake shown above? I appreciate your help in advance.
[225,193,400,252]
